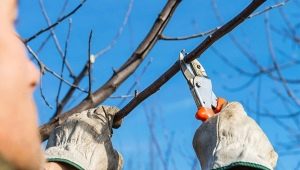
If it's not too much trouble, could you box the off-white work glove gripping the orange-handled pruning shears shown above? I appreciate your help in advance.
[193,102,278,170]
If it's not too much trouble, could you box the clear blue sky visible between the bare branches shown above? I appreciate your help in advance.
[17,0,300,169]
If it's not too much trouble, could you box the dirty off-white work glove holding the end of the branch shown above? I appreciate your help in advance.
[45,106,123,170]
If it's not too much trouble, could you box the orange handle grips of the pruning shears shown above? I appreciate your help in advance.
[195,98,227,122]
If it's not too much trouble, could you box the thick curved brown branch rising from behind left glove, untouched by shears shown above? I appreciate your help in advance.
[40,0,180,140]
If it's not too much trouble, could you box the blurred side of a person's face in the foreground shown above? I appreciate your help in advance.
[0,0,42,170]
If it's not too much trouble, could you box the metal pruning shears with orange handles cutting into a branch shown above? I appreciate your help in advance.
[179,50,227,121]
